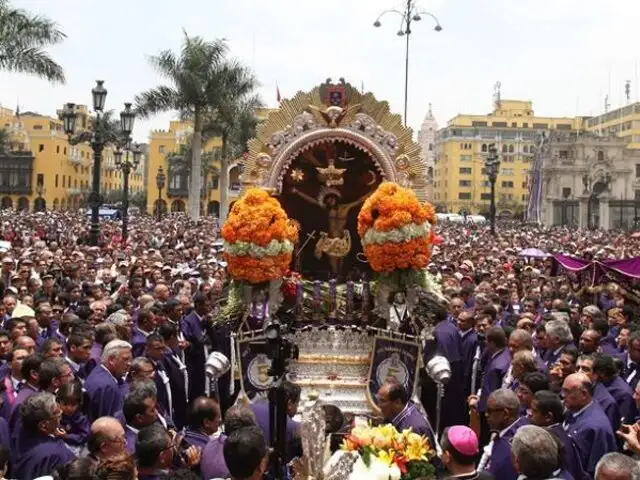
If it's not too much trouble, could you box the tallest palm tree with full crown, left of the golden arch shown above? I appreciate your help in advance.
[136,32,228,219]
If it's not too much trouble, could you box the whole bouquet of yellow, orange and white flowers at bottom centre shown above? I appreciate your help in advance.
[341,425,435,480]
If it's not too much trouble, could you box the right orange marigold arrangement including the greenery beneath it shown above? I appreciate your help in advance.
[358,182,436,316]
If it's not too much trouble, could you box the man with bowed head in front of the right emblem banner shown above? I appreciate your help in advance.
[376,380,438,452]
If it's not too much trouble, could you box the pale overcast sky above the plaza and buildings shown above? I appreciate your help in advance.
[0,0,640,141]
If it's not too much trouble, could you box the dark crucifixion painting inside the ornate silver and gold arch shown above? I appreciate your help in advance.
[280,140,382,280]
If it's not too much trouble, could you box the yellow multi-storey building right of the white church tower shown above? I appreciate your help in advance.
[432,100,583,214]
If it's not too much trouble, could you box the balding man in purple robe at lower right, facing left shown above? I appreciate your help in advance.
[562,373,617,478]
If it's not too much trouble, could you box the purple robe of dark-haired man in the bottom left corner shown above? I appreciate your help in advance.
[11,431,76,480]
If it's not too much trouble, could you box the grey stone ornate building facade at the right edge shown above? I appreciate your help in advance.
[540,132,640,230]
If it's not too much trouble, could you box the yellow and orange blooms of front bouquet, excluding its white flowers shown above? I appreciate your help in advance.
[341,425,435,480]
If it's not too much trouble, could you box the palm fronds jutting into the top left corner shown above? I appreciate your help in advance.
[0,0,66,83]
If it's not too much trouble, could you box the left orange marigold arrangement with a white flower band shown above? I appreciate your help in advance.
[222,188,298,284]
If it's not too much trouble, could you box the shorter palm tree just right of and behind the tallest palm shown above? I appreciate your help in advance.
[199,62,263,224]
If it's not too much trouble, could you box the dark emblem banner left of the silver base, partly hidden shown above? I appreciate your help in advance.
[237,336,273,402]
